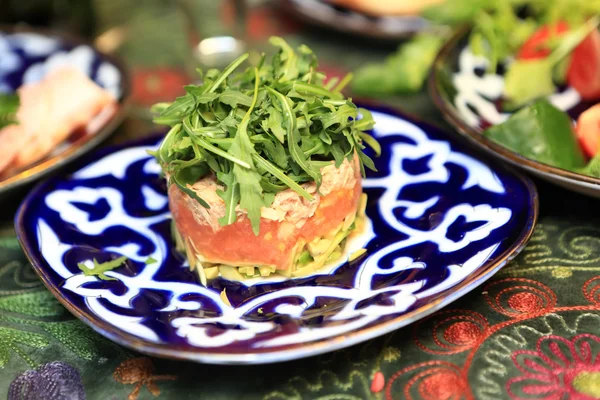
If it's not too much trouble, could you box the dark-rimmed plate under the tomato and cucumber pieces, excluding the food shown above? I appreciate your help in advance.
[429,28,600,197]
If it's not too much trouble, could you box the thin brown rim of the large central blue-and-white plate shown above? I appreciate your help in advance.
[14,101,539,365]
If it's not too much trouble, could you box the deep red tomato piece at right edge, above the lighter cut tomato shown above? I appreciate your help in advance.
[567,30,600,100]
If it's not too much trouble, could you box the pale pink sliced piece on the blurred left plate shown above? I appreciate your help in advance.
[0,67,116,173]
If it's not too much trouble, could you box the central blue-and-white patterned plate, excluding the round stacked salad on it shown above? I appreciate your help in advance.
[16,109,538,364]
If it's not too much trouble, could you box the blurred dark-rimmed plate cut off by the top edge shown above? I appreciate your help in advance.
[280,0,444,40]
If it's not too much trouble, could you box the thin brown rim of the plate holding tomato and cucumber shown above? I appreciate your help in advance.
[428,27,600,189]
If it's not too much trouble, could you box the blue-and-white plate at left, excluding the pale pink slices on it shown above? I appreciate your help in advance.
[0,30,130,195]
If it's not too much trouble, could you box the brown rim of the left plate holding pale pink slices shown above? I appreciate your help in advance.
[0,25,131,194]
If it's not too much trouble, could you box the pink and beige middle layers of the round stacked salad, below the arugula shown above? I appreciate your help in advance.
[168,157,362,270]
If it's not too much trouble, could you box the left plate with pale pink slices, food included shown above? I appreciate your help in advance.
[0,28,129,195]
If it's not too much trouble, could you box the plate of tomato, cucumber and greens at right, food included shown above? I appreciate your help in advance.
[430,0,600,197]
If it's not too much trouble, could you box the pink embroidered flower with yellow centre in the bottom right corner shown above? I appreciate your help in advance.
[506,334,600,400]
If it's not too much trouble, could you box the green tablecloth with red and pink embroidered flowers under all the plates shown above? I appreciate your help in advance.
[0,0,600,400]
